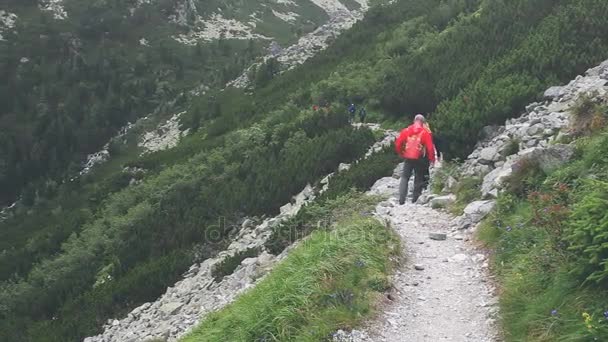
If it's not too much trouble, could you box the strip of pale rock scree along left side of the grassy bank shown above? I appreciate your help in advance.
[85,125,397,342]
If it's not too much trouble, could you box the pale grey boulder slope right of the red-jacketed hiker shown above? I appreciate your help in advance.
[461,61,608,198]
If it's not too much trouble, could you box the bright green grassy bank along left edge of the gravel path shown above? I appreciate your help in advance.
[183,195,400,342]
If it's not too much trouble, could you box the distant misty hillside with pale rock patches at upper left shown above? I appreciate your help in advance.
[0,0,368,205]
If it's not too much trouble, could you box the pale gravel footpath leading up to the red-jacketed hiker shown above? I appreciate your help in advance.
[335,178,500,342]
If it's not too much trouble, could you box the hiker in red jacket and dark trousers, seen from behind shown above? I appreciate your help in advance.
[395,114,435,204]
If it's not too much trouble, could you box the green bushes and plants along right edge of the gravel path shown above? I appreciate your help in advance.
[479,132,608,341]
